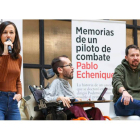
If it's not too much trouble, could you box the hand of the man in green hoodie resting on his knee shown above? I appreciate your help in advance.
[121,91,133,105]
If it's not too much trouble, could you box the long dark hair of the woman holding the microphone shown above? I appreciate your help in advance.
[0,21,21,59]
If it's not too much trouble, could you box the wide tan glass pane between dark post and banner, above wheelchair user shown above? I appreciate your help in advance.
[44,20,71,64]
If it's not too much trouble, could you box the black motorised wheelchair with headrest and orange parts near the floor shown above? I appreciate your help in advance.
[29,69,111,120]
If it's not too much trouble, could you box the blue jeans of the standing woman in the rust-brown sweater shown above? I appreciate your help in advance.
[0,91,21,120]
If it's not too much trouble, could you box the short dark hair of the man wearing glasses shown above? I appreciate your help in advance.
[51,55,68,76]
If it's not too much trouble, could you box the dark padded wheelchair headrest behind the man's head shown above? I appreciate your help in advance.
[41,68,55,80]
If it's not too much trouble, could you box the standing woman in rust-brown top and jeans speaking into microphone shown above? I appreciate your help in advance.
[0,21,22,120]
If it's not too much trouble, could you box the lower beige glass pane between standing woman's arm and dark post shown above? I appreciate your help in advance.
[24,68,40,96]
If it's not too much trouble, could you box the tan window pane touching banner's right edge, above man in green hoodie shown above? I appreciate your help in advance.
[126,29,134,47]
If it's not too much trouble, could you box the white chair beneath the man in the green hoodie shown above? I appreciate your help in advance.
[109,95,140,120]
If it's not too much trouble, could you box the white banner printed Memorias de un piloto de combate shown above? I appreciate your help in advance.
[72,20,126,113]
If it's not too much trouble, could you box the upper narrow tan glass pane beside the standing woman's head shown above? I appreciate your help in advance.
[23,20,39,64]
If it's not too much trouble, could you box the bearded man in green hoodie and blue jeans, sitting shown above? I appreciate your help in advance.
[112,45,140,116]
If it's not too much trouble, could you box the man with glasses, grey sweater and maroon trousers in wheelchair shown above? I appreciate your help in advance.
[42,55,104,120]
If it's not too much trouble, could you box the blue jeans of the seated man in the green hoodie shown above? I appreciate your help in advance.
[114,96,140,116]
